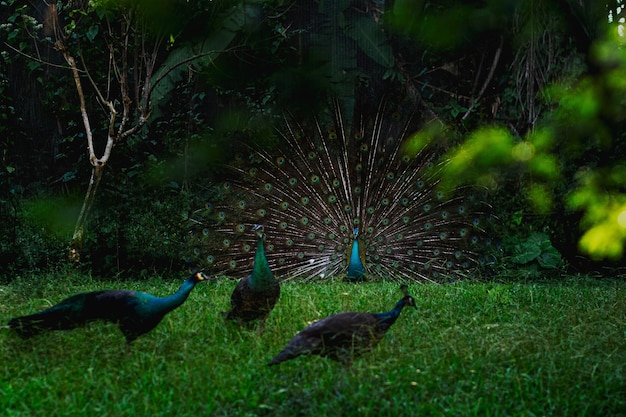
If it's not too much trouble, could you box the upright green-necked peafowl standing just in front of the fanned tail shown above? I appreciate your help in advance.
[222,225,280,323]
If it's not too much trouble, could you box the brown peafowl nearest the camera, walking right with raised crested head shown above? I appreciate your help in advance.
[268,285,417,366]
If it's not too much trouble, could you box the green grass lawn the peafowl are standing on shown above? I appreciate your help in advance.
[0,274,626,417]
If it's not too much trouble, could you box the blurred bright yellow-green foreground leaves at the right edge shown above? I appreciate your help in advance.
[417,20,626,261]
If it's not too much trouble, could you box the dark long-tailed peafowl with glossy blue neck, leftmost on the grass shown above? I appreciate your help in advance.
[8,272,207,344]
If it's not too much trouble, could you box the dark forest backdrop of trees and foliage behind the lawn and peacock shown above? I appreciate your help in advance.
[0,0,626,281]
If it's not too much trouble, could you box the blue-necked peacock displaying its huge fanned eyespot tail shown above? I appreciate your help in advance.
[190,98,481,282]
